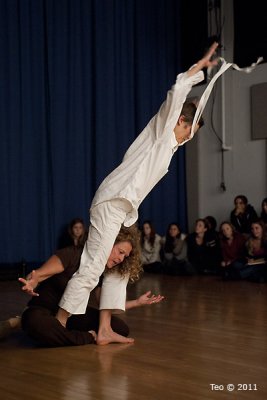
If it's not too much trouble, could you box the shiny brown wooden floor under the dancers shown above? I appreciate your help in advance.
[0,274,267,400]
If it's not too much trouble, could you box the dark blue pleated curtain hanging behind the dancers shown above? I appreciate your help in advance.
[0,0,186,263]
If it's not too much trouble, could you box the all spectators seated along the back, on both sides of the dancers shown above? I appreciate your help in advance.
[57,195,267,280]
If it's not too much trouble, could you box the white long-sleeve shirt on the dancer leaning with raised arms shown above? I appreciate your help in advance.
[91,71,204,226]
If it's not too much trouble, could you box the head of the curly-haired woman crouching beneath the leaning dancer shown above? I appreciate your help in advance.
[106,225,142,281]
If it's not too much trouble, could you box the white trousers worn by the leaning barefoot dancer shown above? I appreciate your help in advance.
[59,199,132,314]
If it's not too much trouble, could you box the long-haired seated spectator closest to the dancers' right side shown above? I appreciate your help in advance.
[141,221,162,272]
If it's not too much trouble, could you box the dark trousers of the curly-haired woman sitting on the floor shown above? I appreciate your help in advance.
[21,307,129,347]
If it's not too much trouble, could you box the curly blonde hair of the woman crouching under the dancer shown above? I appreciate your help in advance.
[106,225,143,282]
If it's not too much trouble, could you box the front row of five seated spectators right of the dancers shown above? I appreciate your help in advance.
[141,216,267,282]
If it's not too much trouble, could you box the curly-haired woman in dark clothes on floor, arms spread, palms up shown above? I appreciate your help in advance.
[8,226,163,347]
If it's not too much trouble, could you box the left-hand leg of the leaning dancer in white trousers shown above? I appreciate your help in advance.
[57,199,132,323]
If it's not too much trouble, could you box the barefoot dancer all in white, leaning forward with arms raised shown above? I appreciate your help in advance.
[57,43,218,344]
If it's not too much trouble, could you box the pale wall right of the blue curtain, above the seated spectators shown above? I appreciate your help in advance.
[186,63,267,230]
